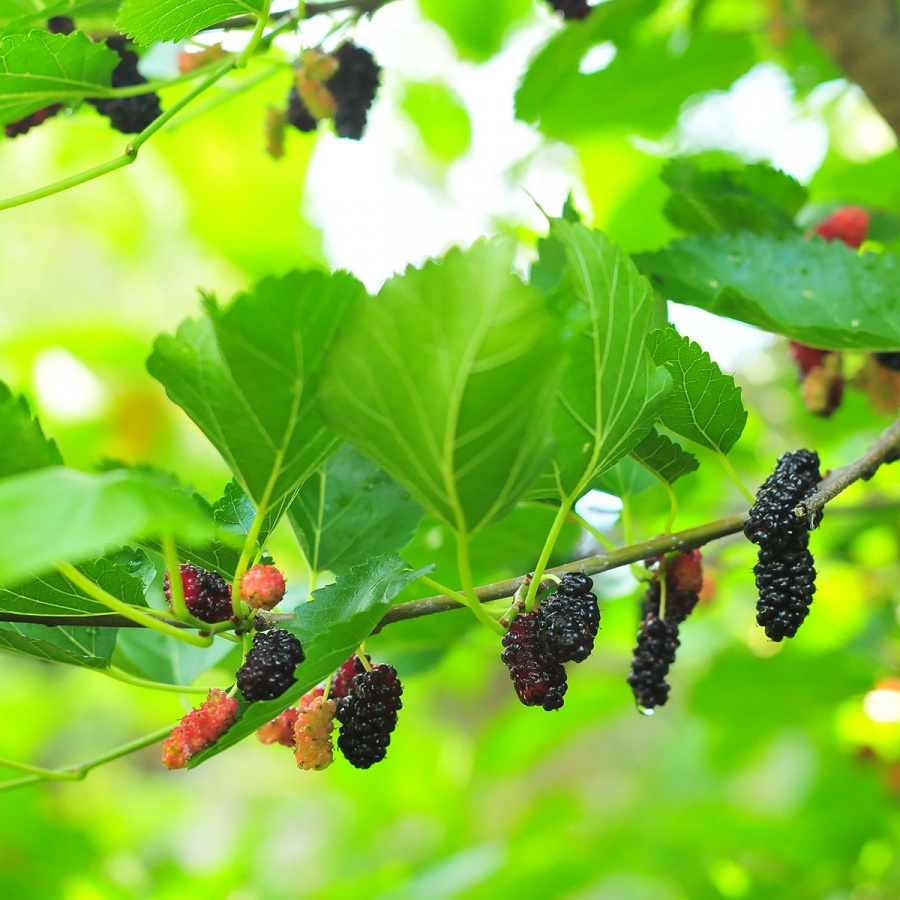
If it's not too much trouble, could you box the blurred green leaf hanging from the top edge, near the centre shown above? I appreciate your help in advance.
[419,0,531,62]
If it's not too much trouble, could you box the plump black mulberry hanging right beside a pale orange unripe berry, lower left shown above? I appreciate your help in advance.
[335,665,403,769]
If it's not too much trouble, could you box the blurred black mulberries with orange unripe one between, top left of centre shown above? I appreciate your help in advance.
[285,41,381,141]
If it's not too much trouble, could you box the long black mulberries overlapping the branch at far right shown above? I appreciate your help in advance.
[744,450,822,641]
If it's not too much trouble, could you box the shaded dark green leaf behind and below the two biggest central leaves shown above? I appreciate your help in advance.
[288,444,423,573]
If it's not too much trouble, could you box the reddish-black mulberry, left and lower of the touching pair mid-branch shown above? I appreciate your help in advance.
[500,611,568,712]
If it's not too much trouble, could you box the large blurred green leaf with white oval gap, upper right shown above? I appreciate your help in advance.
[516,12,756,141]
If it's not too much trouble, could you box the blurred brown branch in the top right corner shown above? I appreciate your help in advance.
[797,0,900,139]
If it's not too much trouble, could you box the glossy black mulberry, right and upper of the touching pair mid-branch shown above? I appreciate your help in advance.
[538,572,600,663]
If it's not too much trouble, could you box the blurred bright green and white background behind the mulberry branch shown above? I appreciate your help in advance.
[0,0,900,900]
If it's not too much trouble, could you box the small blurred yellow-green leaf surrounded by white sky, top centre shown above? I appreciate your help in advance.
[400,81,472,165]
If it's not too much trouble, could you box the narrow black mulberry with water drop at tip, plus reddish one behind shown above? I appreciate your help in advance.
[627,550,703,713]
